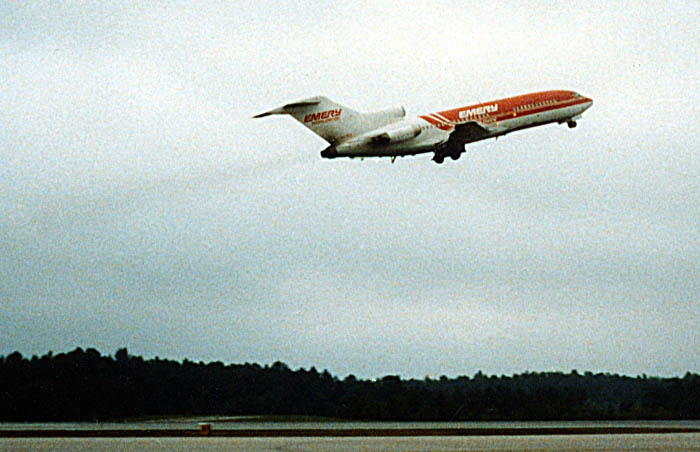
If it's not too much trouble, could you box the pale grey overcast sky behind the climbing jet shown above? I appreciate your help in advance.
[0,1,700,378]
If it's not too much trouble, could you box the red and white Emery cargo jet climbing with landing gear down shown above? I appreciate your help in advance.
[253,90,593,164]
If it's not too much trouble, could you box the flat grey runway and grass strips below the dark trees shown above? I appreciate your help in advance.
[0,419,700,452]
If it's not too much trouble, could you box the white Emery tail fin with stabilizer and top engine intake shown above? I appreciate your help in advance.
[253,96,406,145]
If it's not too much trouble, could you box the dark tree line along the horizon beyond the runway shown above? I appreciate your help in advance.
[0,348,700,421]
